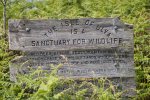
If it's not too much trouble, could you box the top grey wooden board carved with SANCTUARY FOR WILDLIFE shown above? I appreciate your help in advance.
[9,18,133,51]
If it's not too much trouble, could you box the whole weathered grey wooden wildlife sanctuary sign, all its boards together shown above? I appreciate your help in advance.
[9,18,135,95]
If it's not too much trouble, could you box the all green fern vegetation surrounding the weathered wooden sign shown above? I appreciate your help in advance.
[0,0,150,100]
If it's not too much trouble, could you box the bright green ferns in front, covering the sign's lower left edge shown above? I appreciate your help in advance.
[0,65,121,100]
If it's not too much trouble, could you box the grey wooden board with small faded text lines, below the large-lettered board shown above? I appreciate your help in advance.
[11,48,135,81]
